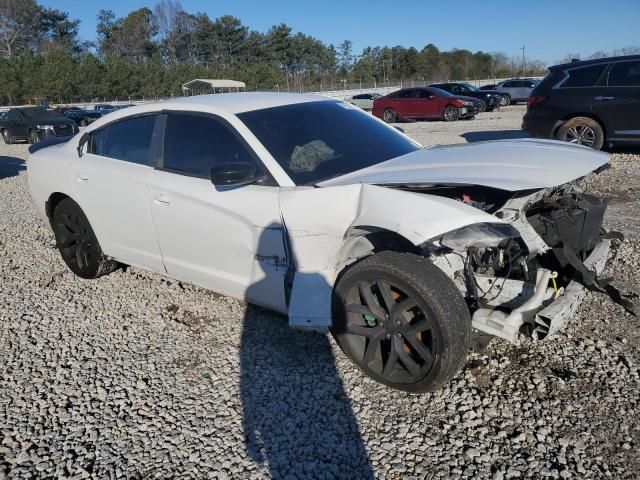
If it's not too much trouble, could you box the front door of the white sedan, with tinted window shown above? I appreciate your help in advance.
[149,112,288,312]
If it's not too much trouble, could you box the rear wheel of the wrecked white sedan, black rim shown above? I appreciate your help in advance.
[51,198,118,278]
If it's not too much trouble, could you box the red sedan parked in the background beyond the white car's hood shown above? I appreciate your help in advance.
[373,87,478,123]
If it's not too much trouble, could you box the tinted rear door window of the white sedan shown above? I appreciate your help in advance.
[89,115,157,165]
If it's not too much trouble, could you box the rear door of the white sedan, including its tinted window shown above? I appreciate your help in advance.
[71,110,164,272]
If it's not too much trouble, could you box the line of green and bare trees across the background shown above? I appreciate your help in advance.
[0,0,636,104]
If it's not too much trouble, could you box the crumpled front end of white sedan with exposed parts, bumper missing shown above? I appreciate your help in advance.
[423,185,611,341]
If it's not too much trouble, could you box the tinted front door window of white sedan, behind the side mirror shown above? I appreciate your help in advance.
[164,114,255,178]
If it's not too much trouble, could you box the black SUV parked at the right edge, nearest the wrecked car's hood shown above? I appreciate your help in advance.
[522,55,640,150]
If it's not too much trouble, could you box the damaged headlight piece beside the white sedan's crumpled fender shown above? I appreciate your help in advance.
[440,223,520,251]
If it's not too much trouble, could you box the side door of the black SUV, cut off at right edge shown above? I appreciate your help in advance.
[593,60,640,141]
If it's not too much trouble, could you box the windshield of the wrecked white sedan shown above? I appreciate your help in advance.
[238,101,420,185]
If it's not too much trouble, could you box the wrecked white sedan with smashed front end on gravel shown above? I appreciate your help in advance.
[27,93,610,392]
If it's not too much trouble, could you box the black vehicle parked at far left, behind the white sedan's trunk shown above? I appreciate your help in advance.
[0,107,78,144]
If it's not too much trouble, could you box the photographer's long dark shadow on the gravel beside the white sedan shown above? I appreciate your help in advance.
[240,227,373,480]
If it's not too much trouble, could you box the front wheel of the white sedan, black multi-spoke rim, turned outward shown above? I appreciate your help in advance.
[332,252,471,393]
